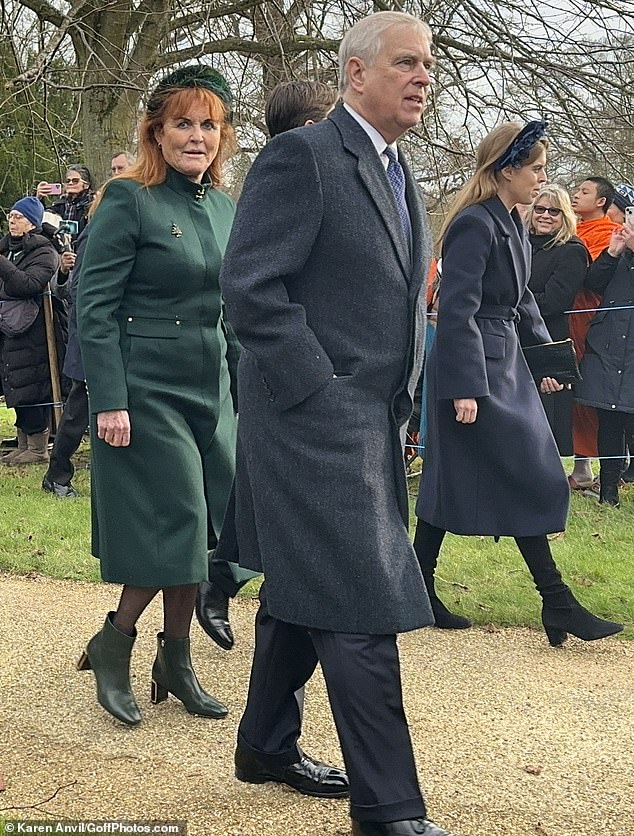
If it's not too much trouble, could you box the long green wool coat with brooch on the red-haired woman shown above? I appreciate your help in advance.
[77,169,239,587]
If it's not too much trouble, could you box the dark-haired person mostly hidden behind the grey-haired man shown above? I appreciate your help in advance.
[196,80,338,650]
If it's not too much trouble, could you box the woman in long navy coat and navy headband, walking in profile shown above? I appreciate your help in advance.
[414,122,623,645]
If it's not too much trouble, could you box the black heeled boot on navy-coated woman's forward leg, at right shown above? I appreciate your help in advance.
[515,534,623,647]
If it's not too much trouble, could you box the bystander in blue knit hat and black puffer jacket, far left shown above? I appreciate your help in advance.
[0,197,67,465]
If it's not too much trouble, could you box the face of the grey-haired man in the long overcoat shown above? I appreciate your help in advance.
[349,24,434,143]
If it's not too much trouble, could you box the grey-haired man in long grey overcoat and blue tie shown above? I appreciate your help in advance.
[221,12,446,836]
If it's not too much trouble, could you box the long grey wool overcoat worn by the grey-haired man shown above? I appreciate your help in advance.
[221,106,433,634]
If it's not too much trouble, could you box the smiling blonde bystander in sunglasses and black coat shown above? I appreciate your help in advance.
[526,185,590,456]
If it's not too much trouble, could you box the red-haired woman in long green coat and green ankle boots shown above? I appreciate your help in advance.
[78,65,239,725]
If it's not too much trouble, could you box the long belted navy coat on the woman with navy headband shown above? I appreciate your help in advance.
[416,197,570,537]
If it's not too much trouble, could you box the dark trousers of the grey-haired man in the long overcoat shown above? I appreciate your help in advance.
[238,584,426,822]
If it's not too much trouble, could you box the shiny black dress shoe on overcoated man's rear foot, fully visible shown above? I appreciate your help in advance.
[235,746,348,800]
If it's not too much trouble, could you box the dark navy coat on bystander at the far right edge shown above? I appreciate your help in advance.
[575,250,634,412]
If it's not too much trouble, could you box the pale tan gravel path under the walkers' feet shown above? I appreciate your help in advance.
[0,575,634,836]
